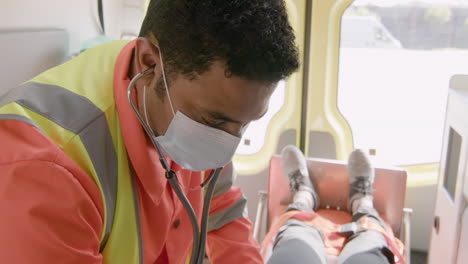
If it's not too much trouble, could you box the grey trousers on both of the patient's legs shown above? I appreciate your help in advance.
[267,208,393,264]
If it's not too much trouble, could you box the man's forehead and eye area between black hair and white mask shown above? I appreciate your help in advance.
[154,62,276,136]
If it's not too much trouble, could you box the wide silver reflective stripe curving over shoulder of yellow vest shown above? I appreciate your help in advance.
[0,82,117,250]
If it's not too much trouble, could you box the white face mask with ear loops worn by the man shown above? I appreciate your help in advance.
[143,48,241,171]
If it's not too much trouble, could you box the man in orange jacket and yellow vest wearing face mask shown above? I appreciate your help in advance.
[0,0,298,264]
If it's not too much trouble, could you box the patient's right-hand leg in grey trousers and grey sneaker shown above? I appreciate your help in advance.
[338,150,393,264]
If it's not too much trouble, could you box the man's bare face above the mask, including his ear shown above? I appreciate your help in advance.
[130,38,276,136]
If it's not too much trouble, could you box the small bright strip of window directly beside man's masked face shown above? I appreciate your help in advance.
[236,81,286,155]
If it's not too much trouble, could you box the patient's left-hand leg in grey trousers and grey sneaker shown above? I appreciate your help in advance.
[268,146,326,264]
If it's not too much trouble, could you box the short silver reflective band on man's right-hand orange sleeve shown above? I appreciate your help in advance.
[208,196,247,232]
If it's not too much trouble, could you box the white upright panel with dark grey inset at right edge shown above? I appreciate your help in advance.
[428,75,468,264]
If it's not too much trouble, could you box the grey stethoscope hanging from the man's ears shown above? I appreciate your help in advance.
[127,64,222,264]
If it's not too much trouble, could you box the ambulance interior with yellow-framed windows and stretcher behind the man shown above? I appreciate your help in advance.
[0,0,468,264]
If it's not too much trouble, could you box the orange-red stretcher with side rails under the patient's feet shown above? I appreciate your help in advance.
[254,156,412,263]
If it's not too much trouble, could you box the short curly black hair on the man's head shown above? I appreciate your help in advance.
[140,0,299,82]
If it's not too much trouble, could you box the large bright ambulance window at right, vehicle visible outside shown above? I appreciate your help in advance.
[338,0,468,165]
